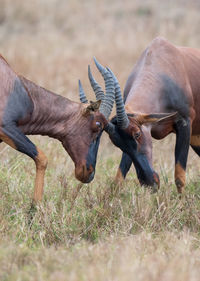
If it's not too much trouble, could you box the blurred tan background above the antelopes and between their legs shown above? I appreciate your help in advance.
[0,0,200,182]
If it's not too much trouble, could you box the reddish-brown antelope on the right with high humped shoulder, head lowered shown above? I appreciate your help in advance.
[91,38,200,193]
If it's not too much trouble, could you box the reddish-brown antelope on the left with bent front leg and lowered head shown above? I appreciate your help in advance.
[0,56,115,201]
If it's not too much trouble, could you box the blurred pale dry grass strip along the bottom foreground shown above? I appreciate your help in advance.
[0,232,200,281]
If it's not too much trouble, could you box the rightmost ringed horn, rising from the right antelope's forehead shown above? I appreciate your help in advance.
[107,68,129,129]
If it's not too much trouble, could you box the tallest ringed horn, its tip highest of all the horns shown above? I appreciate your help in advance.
[94,58,115,120]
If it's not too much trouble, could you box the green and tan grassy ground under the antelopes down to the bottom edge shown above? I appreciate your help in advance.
[0,152,200,281]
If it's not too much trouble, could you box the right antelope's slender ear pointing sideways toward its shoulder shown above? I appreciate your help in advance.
[134,112,178,125]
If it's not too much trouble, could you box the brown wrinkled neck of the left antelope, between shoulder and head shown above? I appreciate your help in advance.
[19,77,80,139]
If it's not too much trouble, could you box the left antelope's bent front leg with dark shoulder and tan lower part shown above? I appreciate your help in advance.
[0,78,47,202]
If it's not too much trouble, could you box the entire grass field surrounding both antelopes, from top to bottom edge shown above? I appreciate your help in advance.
[0,0,200,281]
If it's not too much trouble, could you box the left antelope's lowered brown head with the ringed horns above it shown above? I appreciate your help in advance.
[62,59,115,183]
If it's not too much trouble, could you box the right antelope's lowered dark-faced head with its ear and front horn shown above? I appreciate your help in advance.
[101,68,176,190]
